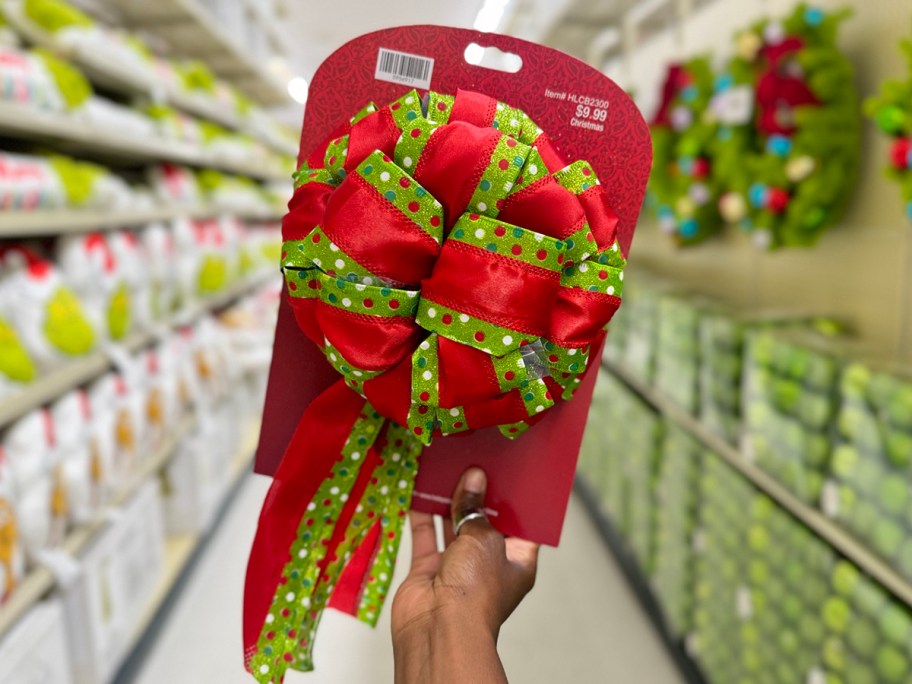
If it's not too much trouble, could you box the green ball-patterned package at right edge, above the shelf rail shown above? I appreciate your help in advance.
[821,362,912,580]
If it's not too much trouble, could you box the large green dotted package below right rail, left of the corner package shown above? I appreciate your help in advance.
[690,453,832,684]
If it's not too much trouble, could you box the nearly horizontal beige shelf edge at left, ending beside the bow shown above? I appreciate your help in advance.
[0,206,284,239]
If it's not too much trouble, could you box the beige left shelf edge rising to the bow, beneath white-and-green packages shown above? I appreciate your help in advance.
[0,273,274,427]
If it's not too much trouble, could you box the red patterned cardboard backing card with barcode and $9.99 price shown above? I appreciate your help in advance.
[255,26,652,545]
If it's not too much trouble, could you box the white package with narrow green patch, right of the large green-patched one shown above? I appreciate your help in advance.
[57,233,136,342]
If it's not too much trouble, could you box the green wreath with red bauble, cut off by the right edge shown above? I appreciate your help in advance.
[865,26,912,221]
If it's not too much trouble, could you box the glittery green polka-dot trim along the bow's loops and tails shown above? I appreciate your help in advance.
[250,91,624,684]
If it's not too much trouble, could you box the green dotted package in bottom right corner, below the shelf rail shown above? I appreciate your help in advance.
[819,560,912,684]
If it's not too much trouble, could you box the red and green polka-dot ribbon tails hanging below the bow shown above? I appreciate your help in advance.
[244,381,421,684]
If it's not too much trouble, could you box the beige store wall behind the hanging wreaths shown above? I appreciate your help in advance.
[611,0,912,363]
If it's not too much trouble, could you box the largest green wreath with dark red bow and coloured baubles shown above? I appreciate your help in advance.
[716,5,860,249]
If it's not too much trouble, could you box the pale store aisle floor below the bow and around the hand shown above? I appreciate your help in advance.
[123,475,683,684]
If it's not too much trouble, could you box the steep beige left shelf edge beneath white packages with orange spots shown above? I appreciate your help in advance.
[0,416,196,637]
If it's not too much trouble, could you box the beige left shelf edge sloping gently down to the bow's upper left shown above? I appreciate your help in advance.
[0,103,292,181]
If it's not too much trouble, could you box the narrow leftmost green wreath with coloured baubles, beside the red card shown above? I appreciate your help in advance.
[649,57,722,245]
